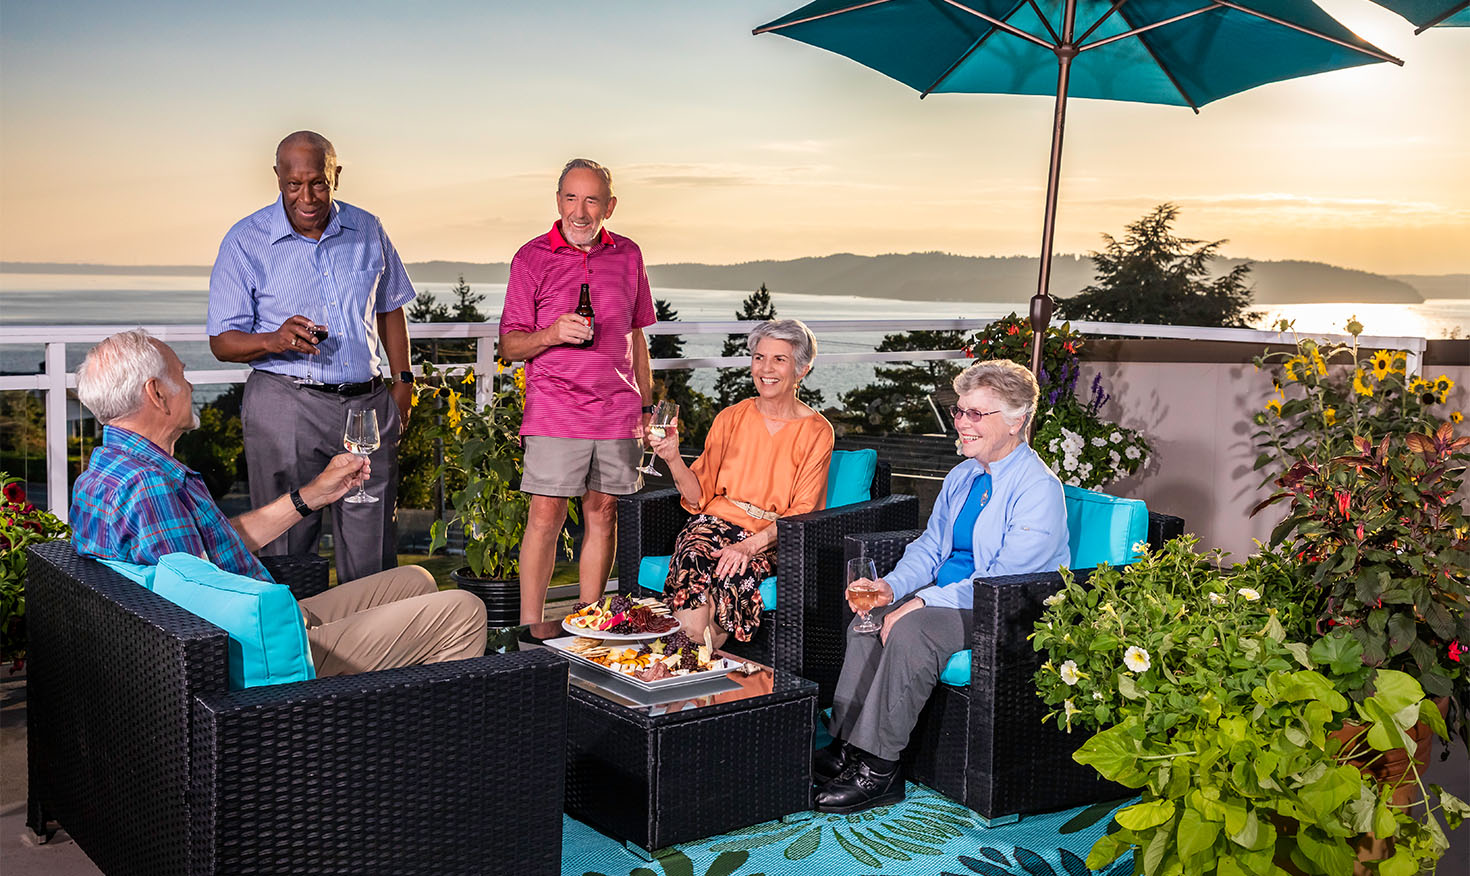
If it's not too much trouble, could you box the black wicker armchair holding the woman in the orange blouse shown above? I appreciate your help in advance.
[617,460,919,706]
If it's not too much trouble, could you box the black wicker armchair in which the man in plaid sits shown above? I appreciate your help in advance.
[26,541,567,876]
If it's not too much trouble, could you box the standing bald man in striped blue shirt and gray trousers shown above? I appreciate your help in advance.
[207,131,415,581]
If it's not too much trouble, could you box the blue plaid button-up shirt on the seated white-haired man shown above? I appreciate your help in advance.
[71,426,273,581]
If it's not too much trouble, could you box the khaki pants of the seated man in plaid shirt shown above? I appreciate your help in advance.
[300,566,485,676]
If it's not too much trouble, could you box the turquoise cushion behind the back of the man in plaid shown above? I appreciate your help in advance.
[153,553,316,691]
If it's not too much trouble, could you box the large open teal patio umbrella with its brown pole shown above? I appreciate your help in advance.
[754,0,1402,375]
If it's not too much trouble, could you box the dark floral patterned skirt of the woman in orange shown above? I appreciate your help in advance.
[663,514,776,642]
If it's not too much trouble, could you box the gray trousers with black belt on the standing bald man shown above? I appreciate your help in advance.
[240,370,401,581]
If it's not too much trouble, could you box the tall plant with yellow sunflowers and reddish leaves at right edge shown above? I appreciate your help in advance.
[1255,320,1470,744]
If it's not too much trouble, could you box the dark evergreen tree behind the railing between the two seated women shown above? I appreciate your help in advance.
[836,332,964,435]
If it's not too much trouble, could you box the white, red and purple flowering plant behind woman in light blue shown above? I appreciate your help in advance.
[964,313,1150,489]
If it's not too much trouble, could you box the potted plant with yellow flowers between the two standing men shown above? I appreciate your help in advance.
[412,363,576,626]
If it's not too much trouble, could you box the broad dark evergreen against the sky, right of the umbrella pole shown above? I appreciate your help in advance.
[1057,203,1255,328]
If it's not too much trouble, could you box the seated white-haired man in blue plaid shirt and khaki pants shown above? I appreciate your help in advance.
[71,329,485,676]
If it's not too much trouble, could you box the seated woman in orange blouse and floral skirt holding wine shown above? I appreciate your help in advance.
[651,319,832,648]
